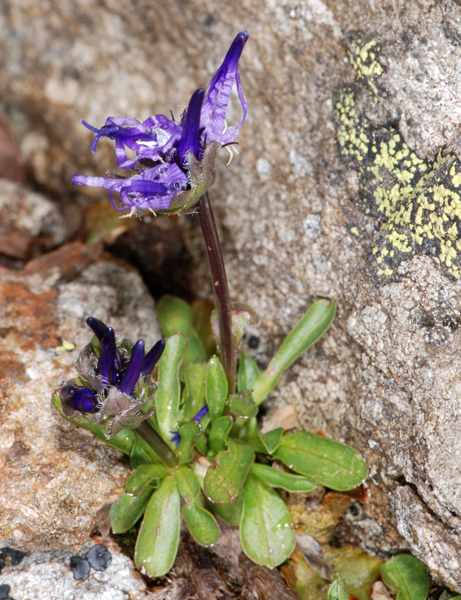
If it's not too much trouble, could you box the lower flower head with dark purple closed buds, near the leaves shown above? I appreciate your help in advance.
[59,317,165,437]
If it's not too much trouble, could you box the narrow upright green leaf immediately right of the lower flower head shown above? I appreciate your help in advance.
[155,334,186,440]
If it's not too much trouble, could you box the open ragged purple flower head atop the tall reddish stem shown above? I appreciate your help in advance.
[72,32,248,213]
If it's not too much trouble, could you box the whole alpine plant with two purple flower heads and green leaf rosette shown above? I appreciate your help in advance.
[54,32,367,577]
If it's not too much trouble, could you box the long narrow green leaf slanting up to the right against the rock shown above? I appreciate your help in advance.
[253,300,336,404]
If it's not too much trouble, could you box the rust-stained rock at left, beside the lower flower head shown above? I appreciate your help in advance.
[0,244,159,550]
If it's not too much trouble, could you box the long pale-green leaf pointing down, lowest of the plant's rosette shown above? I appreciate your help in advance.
[134,475,181,577]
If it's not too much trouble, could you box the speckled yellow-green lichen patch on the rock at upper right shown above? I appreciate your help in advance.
[335,38,461,278]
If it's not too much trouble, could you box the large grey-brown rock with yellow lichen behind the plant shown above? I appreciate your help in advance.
[0,0,461,590]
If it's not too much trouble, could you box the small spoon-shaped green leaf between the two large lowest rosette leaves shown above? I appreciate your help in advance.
[175,467,220,546]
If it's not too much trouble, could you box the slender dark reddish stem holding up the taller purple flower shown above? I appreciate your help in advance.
[197,192,236,394]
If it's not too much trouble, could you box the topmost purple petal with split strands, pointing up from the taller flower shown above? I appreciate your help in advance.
[200,31,248,145]
